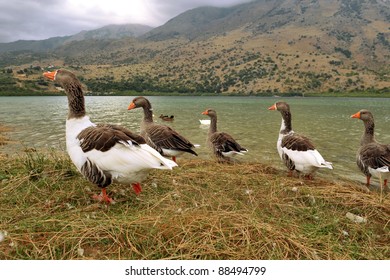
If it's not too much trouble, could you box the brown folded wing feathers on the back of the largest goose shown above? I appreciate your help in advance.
[77,124,146,153]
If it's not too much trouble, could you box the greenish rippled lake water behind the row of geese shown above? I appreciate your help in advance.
[0,96,390,182]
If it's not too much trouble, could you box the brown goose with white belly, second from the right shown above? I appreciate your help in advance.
[268,101,333,179]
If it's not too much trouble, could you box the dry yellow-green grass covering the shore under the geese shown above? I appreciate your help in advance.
[0,149,390,260]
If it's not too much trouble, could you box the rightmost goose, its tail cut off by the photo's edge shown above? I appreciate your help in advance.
[351,109,390,187]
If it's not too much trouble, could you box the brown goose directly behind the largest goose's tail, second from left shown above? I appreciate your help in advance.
[127,96,198,162]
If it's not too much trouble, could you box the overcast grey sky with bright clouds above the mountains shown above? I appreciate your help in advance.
[0,0,250,43]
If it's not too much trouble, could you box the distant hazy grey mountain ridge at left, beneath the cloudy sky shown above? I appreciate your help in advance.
[0,24,153,53]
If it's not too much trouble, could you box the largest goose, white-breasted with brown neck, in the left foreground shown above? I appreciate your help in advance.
[43,69,177,204]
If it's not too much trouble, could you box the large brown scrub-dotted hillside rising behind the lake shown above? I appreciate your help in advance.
[0,0,390,95]
